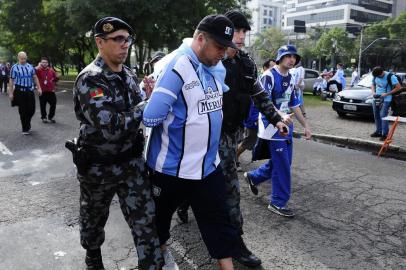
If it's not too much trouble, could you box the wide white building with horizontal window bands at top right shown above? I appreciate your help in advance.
[282,0,392,33]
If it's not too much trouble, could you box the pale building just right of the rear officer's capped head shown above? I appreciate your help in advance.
[246,0,283,46]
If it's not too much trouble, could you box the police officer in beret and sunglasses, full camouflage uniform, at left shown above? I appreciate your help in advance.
[74,17,162,270]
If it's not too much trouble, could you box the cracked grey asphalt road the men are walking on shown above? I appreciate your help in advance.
[0,89,406,270]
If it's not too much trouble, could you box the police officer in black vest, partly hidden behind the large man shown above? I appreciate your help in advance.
[219,10,291,267]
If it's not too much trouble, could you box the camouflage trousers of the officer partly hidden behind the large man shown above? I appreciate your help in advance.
[219,131,243,235]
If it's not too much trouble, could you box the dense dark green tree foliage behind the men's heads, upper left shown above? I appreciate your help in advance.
[0,0,239,74]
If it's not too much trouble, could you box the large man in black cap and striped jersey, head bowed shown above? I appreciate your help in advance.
[143,15,285,269]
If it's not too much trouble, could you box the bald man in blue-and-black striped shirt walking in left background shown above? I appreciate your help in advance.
[9,52,42,135]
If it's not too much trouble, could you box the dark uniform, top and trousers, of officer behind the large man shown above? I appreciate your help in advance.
[219,50,281,234]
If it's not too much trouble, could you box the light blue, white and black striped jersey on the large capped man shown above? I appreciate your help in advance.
[143,54,223,180]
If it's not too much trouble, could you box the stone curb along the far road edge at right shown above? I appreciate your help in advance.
[293,131,406,160]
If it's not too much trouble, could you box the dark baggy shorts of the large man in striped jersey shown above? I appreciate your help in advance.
[152,168,241,259]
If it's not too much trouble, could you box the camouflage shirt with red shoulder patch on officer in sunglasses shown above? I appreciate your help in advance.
[73,56,142,156]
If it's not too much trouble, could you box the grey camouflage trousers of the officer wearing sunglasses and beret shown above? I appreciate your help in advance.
[78,158,162,270]
